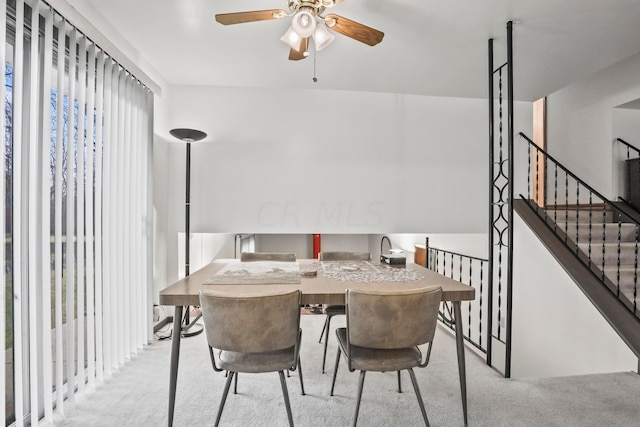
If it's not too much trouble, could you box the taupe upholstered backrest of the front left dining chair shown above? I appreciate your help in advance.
[200,290,301,353]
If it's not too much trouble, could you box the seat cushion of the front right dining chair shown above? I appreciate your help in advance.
[336,328,422,372]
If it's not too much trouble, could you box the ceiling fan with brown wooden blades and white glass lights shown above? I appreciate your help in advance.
[215,0,384,61]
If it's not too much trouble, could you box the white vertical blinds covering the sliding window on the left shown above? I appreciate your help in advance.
[0,0,153,426]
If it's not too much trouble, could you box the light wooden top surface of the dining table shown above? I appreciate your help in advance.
[160,259,475,306]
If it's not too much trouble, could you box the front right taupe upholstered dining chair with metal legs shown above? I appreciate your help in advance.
[331,287,442,426]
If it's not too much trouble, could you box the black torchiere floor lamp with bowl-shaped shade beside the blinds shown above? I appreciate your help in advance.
[169,128,207,337]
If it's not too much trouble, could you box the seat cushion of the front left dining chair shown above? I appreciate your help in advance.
[218,347,295,373]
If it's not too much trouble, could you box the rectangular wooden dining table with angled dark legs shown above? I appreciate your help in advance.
[159,259,475,426]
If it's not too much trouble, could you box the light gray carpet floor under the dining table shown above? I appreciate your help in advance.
[46,315,640,427]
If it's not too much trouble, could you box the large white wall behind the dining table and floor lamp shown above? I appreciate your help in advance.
[162,86,531,234]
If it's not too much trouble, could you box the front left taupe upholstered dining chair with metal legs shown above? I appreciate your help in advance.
[200,290,304,426]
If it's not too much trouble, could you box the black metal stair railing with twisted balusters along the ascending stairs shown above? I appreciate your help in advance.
[520,133,640,318]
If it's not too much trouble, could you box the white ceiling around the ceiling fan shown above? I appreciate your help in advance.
[63,0,640,101]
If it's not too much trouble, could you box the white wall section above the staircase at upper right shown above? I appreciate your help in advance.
[547,51,640,198]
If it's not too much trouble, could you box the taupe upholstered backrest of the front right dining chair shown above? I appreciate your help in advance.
[347,287,442,349]
